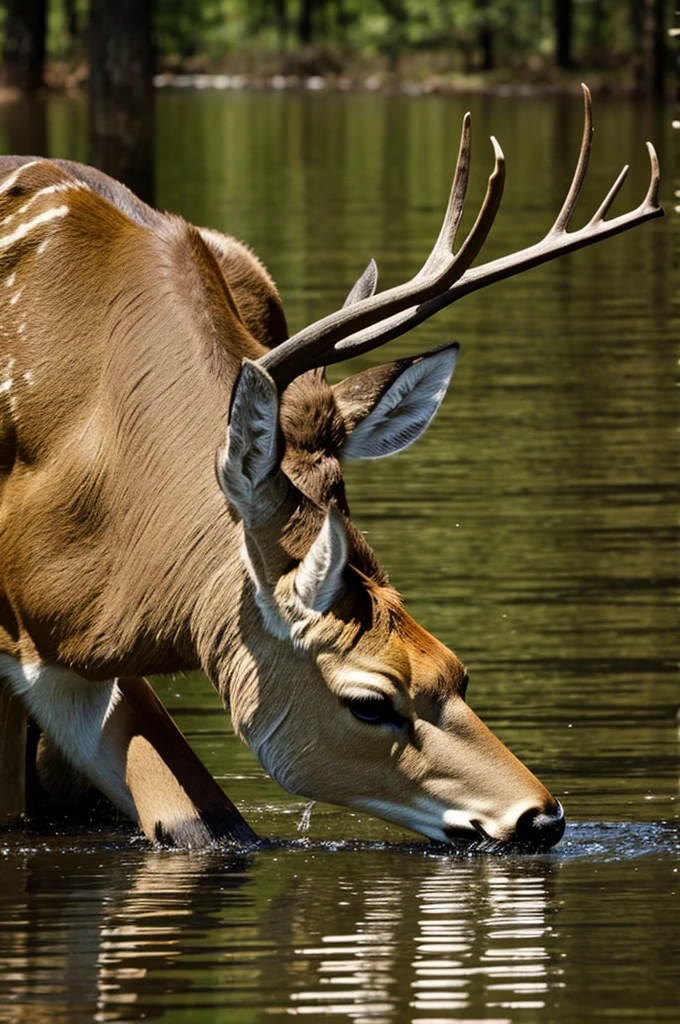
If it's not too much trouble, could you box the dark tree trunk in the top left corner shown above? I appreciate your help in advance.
[2,0,47,93]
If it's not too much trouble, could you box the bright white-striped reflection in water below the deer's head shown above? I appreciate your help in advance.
[272,859,551,1024]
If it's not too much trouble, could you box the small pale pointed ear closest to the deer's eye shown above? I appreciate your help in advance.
[295,505,347,612]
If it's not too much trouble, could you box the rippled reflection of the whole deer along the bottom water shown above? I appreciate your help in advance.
[0,845,559,1024]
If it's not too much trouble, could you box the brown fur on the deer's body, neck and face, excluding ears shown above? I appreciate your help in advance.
[0,160,554,842]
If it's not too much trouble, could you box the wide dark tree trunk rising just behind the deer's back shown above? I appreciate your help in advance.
[89,0,155,203]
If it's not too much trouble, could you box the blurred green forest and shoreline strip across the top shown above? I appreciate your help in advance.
[0,0,678,95]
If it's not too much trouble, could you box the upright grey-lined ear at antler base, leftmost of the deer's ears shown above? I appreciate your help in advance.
[216,359,288,527]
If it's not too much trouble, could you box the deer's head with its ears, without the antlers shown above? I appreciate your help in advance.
[218,346,564,849]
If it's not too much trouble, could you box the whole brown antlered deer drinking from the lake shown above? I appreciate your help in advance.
[0,86,663,851]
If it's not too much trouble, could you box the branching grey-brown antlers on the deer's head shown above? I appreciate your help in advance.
[258,85,664,391]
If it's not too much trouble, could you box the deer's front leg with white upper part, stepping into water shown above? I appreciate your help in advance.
[0,655,257,847]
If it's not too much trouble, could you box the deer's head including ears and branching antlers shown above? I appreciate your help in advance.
[217,87,662,848]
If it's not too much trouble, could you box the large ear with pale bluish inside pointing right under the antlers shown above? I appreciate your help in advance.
[333,342,459,461]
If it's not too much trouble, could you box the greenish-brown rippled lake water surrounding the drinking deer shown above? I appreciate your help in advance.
[0,93,680,1024]
